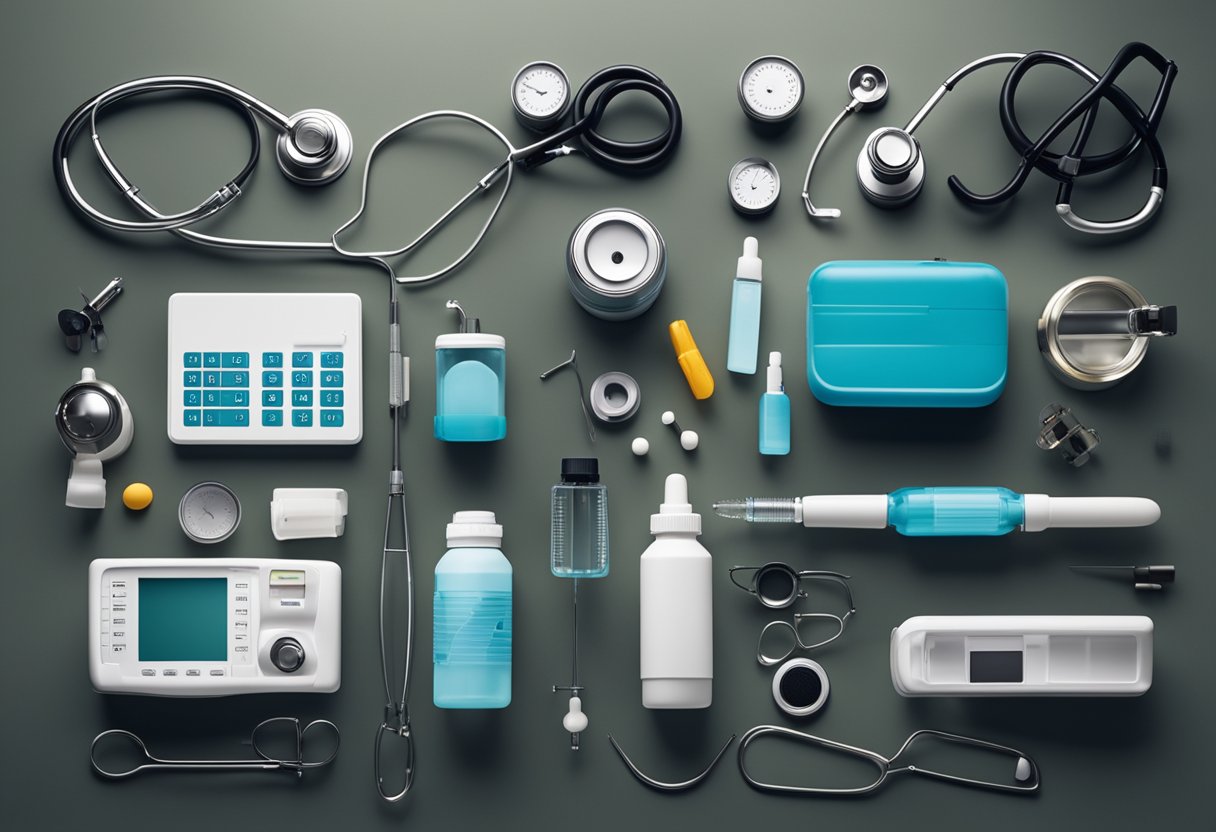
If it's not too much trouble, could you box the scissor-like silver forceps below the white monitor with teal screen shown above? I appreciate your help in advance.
[89,716,340,780]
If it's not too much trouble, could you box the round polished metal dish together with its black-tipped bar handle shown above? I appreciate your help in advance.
[1037,277,1178,389]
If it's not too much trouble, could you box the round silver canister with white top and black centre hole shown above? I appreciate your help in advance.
[565,208,668,321]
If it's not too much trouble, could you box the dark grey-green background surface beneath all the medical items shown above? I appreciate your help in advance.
[0,0,1216,830]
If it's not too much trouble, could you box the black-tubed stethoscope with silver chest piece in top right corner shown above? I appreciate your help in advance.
[857,43,1178,234]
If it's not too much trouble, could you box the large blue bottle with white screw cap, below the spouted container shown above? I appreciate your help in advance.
[434,511,512,708]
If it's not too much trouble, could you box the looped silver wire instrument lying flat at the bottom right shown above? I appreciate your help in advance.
[738,725,1040,796]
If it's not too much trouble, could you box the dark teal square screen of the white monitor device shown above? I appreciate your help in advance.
[139,578,229,662]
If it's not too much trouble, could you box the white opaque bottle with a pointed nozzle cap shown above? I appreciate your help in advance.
[641,474,714,708]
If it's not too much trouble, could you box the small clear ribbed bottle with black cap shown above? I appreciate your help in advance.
[550,456,608,578]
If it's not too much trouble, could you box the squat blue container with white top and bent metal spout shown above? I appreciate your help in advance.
[435,300,507,442]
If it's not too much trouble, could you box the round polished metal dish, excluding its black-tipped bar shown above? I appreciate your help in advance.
[1038,276,1148,389]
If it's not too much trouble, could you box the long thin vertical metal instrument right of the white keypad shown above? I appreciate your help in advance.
[373,281,413,803]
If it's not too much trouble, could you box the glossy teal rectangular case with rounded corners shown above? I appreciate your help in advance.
[806,260,1009,407]
